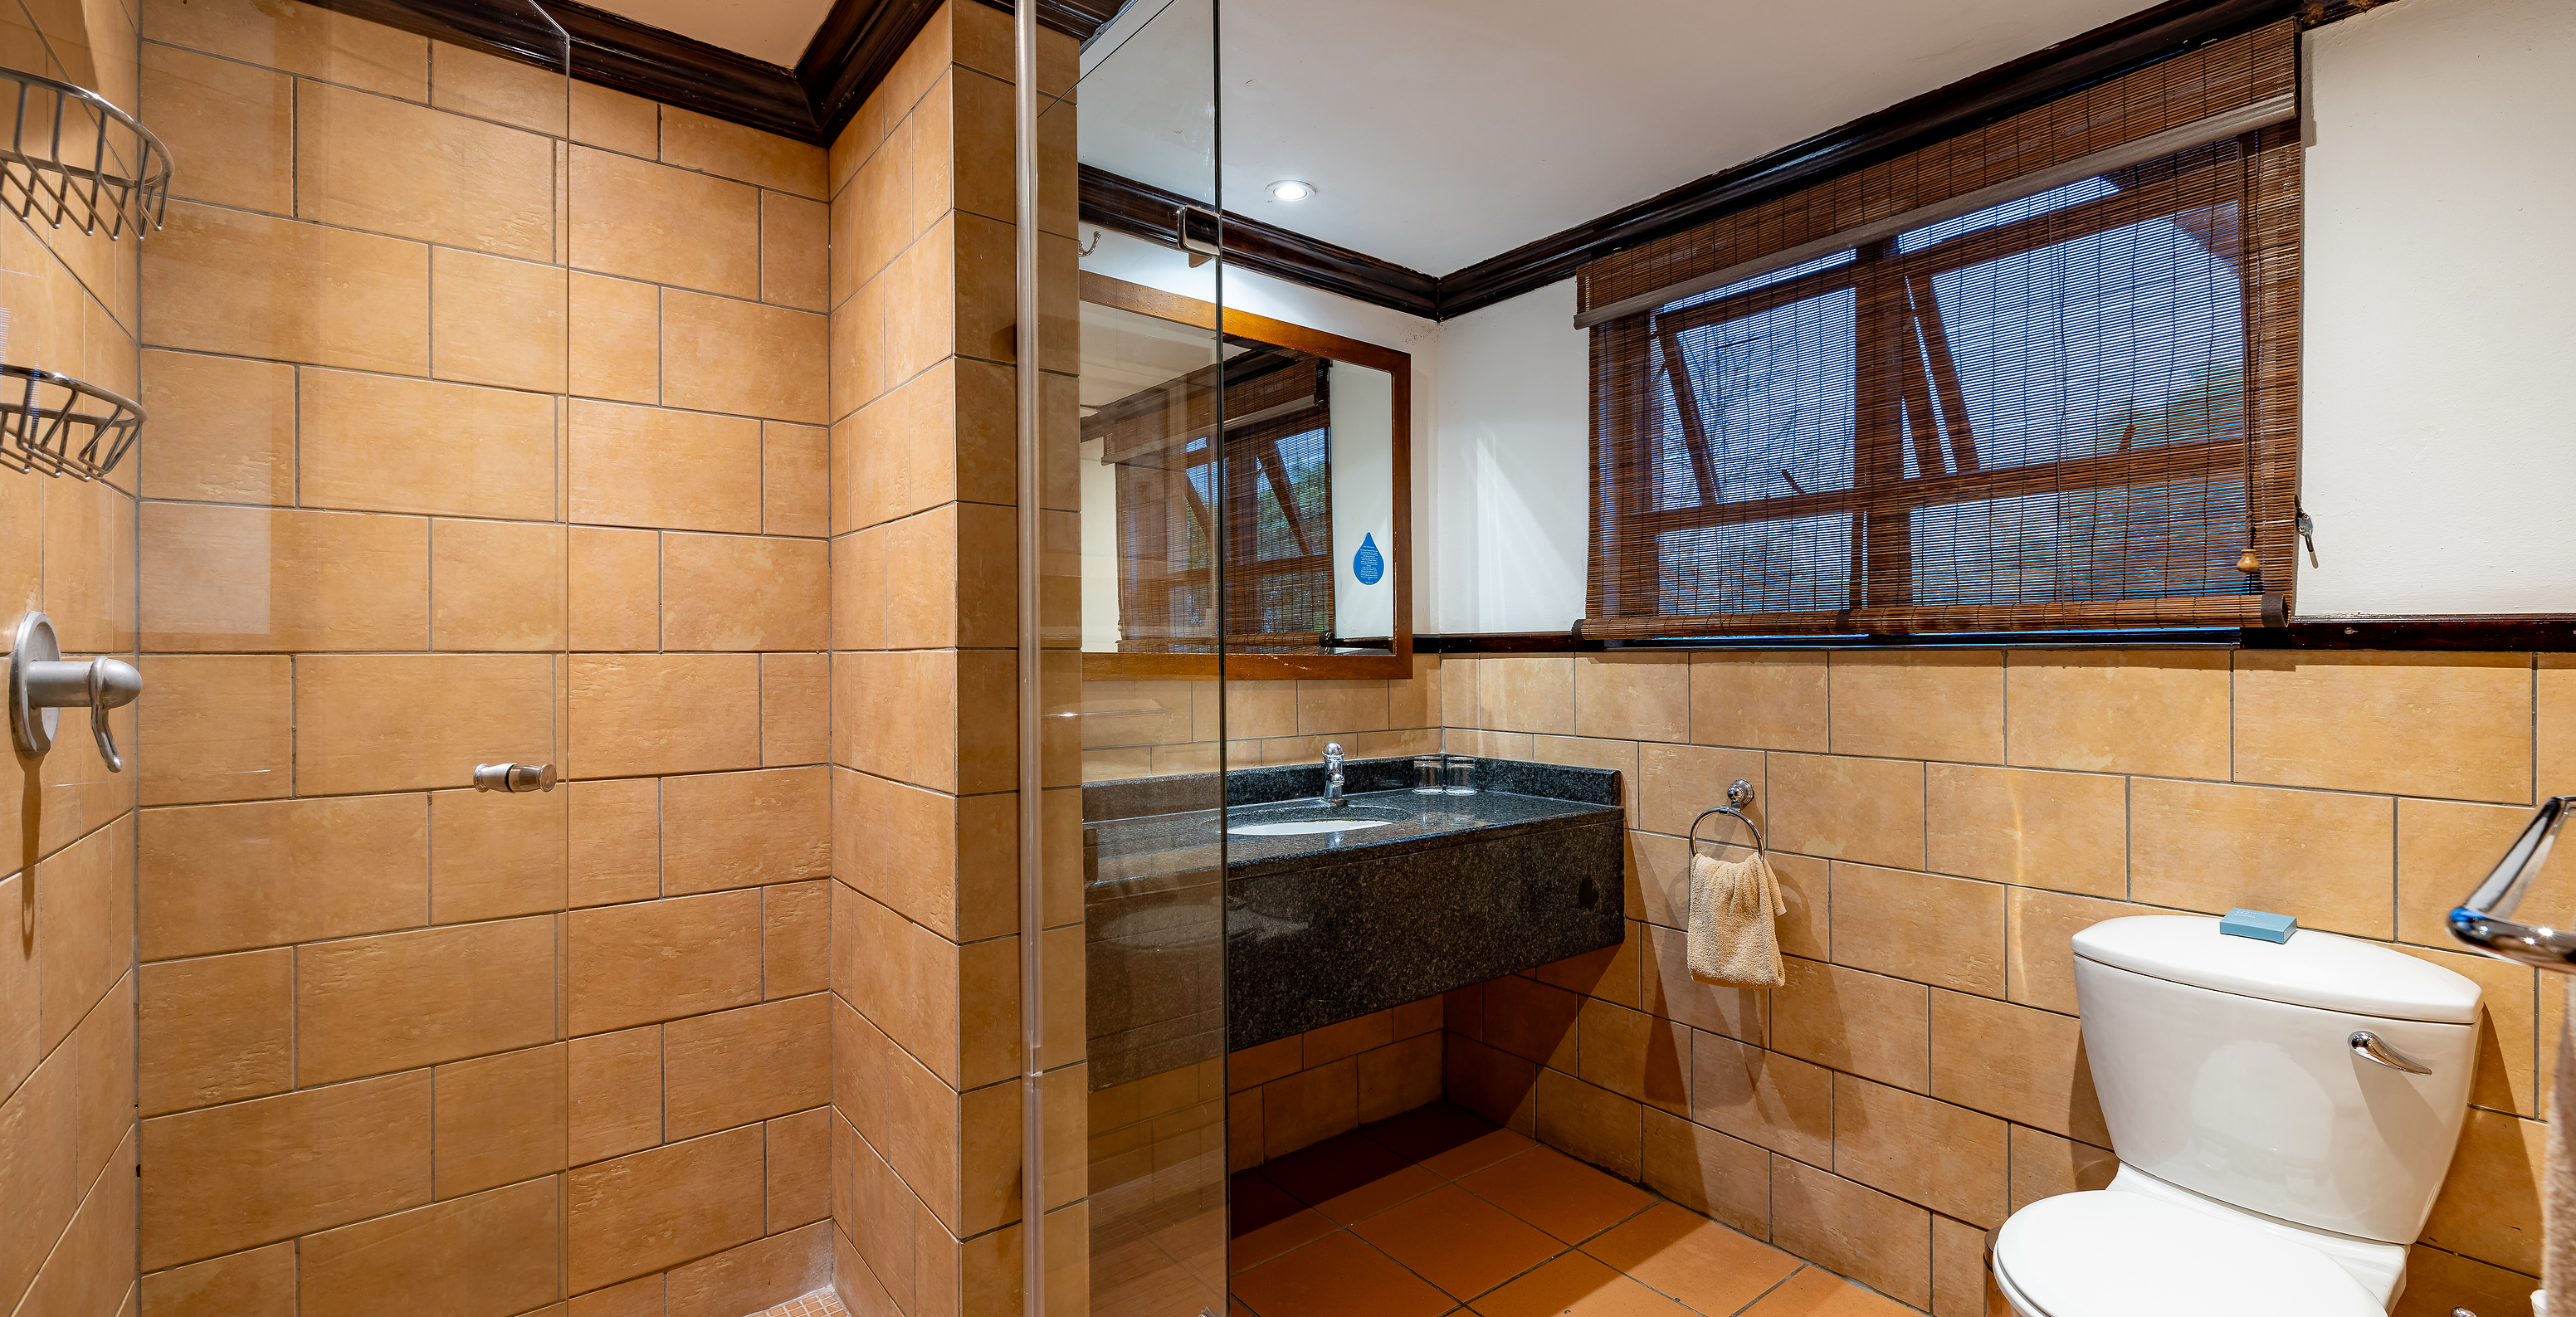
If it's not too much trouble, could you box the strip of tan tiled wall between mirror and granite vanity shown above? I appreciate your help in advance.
[1082,655,1440,781]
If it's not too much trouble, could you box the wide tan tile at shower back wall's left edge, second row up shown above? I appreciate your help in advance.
[142,1070,430,1271]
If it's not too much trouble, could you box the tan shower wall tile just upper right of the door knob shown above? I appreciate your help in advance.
[569,655,760,778]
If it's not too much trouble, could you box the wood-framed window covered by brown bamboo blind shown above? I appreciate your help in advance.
[1579,23,2298,637]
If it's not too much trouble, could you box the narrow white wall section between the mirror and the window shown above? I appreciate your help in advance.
[1422,278,1592,634]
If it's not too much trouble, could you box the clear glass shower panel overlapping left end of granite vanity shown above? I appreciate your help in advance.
[1041,0,1229,1317]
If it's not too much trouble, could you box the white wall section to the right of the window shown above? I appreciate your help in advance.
[2298,0,2576,613]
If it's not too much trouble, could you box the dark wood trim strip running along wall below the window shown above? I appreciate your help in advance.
[1414,613,2576,655]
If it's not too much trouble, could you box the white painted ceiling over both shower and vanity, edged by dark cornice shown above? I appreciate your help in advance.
[605,0,2144,276]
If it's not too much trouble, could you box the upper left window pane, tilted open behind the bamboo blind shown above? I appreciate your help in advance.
[1654,289,1857,510]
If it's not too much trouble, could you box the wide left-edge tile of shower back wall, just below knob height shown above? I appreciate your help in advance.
[134,797,430,961]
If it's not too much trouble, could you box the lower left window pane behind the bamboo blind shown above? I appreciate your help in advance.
[1654,513,1852,616]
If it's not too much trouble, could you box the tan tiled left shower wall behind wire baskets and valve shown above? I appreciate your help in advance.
[0,2,137,1315]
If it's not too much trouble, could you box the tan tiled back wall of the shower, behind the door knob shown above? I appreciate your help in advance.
[137,0,829,1317]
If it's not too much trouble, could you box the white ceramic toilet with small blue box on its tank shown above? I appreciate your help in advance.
[1993,915,2478,1317]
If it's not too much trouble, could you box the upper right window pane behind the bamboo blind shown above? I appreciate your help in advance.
[1932,203,2247,466]
